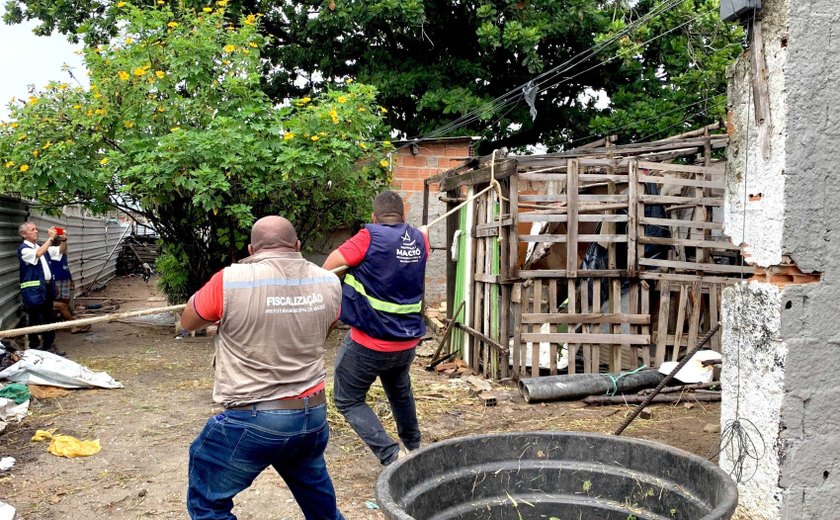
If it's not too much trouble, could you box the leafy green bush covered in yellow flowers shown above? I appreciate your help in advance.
[0,4,392,301]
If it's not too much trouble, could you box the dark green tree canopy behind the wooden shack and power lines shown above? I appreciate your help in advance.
[6,0,742,150]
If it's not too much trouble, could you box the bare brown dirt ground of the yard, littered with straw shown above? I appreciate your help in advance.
[0,277,720,520]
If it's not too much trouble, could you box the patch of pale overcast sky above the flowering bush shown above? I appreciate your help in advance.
[0,9,87,120]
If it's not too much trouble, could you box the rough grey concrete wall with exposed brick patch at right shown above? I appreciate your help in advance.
[721,0,840,520]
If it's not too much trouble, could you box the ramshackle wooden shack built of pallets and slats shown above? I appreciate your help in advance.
[423,128,753,378]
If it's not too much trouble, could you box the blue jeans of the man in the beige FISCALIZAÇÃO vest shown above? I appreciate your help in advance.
[187,404,344,520]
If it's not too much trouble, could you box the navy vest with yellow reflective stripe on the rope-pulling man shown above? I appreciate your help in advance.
[341,223,428,341]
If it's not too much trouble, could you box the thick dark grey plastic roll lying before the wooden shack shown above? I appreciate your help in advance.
[519,370,665,403]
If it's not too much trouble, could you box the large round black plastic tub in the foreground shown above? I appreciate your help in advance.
[376,432,738,520]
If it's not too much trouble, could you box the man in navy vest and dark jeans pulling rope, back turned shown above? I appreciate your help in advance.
[324,191,429,465]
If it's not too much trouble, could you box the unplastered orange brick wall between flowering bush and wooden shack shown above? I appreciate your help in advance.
[392,137,474,307]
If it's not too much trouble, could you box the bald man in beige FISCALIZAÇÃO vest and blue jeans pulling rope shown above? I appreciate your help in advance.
[181,216,343,520]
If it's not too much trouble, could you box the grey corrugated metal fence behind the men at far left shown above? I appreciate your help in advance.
[0,197,131,329]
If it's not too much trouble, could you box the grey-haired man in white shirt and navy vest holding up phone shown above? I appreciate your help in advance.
[17,222,66,356]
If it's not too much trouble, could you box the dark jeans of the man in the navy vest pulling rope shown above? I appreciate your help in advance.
[333,334,420,465]
